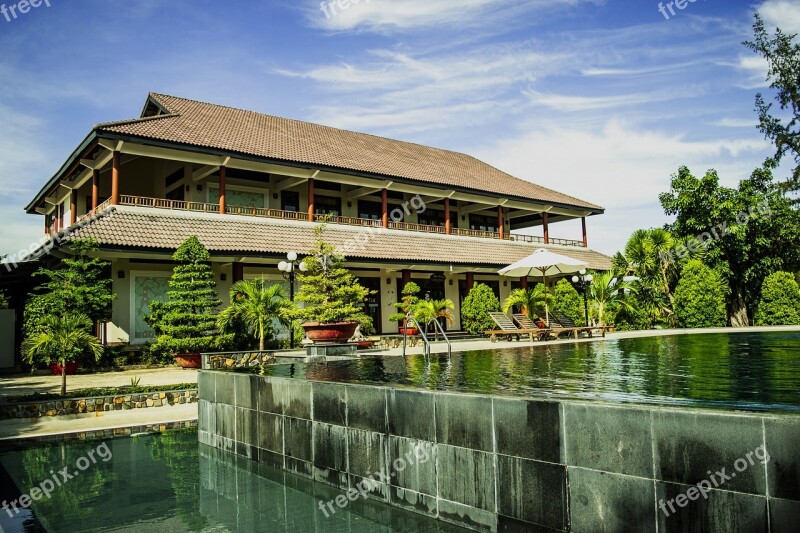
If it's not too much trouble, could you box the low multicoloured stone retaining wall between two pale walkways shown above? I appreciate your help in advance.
[0,389,197,420]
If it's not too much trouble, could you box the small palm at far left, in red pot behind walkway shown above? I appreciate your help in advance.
[22,313,103,396]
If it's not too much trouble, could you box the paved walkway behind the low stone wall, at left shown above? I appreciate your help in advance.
[0,367,197,397]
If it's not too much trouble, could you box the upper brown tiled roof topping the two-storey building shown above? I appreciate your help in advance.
[96,93,603,211]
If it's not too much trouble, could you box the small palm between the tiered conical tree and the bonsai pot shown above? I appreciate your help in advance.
[217,279,292,352]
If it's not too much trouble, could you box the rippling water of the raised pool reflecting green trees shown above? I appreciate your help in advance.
[271,333,800,411]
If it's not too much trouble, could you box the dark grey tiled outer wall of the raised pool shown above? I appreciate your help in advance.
[199,371,800,533]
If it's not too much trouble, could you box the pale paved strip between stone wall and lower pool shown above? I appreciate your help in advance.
[0,403,197,441]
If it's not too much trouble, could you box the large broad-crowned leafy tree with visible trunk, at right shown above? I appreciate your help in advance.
[659,167,800,327]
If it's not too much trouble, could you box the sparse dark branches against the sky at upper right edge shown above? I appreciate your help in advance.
[742,13,800,191]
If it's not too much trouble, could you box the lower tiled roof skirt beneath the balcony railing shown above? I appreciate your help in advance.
[69,206,611,270]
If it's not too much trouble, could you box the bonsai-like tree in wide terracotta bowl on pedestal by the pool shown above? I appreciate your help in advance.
[286,224,371,343]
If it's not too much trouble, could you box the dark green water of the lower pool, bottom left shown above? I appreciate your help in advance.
[0,431,464,533]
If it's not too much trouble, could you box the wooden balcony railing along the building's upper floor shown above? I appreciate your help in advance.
[80,194,584,248]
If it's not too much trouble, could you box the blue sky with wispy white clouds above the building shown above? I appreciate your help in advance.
[0,0,800,253]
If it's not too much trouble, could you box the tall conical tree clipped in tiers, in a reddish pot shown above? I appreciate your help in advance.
[147,236,233,368]
